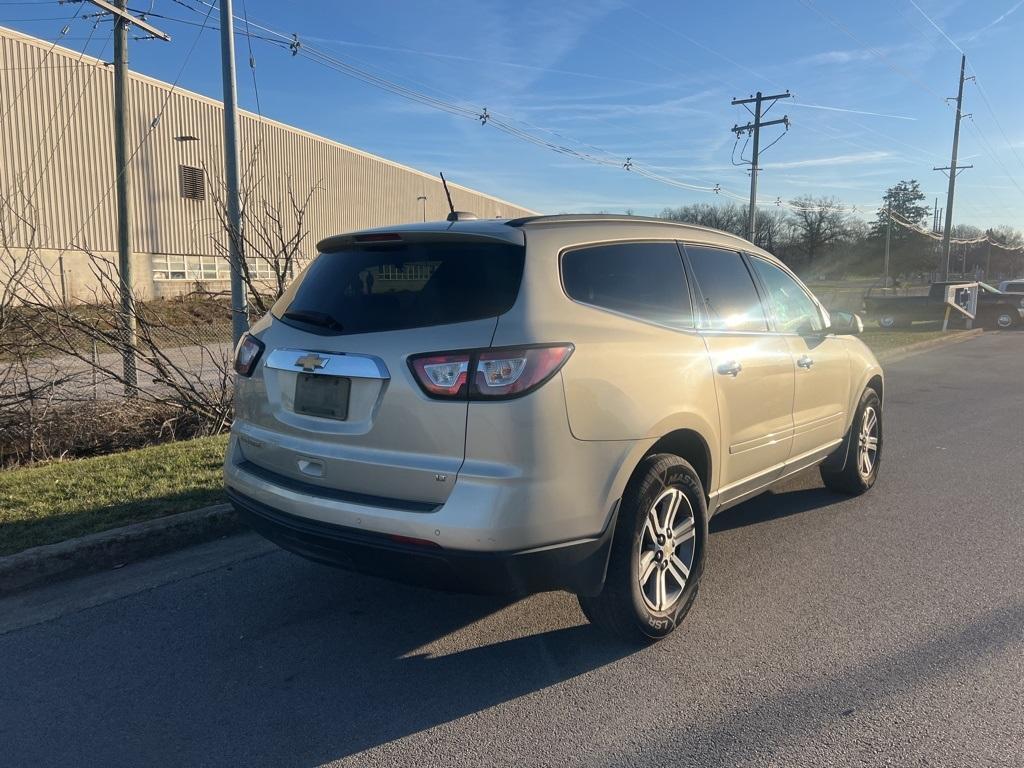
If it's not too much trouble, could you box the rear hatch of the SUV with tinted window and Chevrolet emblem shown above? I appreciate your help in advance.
[236,234,525,510]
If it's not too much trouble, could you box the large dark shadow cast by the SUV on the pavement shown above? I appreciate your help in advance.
[0,551,637,766]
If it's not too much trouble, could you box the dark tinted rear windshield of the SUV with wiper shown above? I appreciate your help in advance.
[272,243,524,334]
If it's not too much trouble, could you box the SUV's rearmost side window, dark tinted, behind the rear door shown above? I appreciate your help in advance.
[562,243,693,328]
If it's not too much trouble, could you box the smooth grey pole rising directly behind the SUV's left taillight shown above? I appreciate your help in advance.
[220,0,249,344]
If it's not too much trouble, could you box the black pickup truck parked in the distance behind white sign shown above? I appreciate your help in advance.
[864,281,1024,330]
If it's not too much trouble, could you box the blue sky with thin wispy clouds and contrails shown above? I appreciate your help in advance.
[6,0,1024,228]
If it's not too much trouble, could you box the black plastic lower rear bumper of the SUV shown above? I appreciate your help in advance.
[227,486,616,595]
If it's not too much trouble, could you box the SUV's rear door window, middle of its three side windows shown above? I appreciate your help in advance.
[686,246,768,331]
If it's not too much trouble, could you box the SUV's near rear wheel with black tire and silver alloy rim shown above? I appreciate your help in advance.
[579,454,708,643]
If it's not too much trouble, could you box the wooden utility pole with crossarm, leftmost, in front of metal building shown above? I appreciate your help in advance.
[89,0,171,397]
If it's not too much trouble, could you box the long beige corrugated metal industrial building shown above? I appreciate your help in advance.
[0,28,532,301]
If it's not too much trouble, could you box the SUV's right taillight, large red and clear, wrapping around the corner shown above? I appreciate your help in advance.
[409,344,573,400]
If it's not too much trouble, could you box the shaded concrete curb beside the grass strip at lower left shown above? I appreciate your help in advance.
[0,504,244,597]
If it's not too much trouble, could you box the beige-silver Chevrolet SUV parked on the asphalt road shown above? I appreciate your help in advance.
[224,215,883,640]
